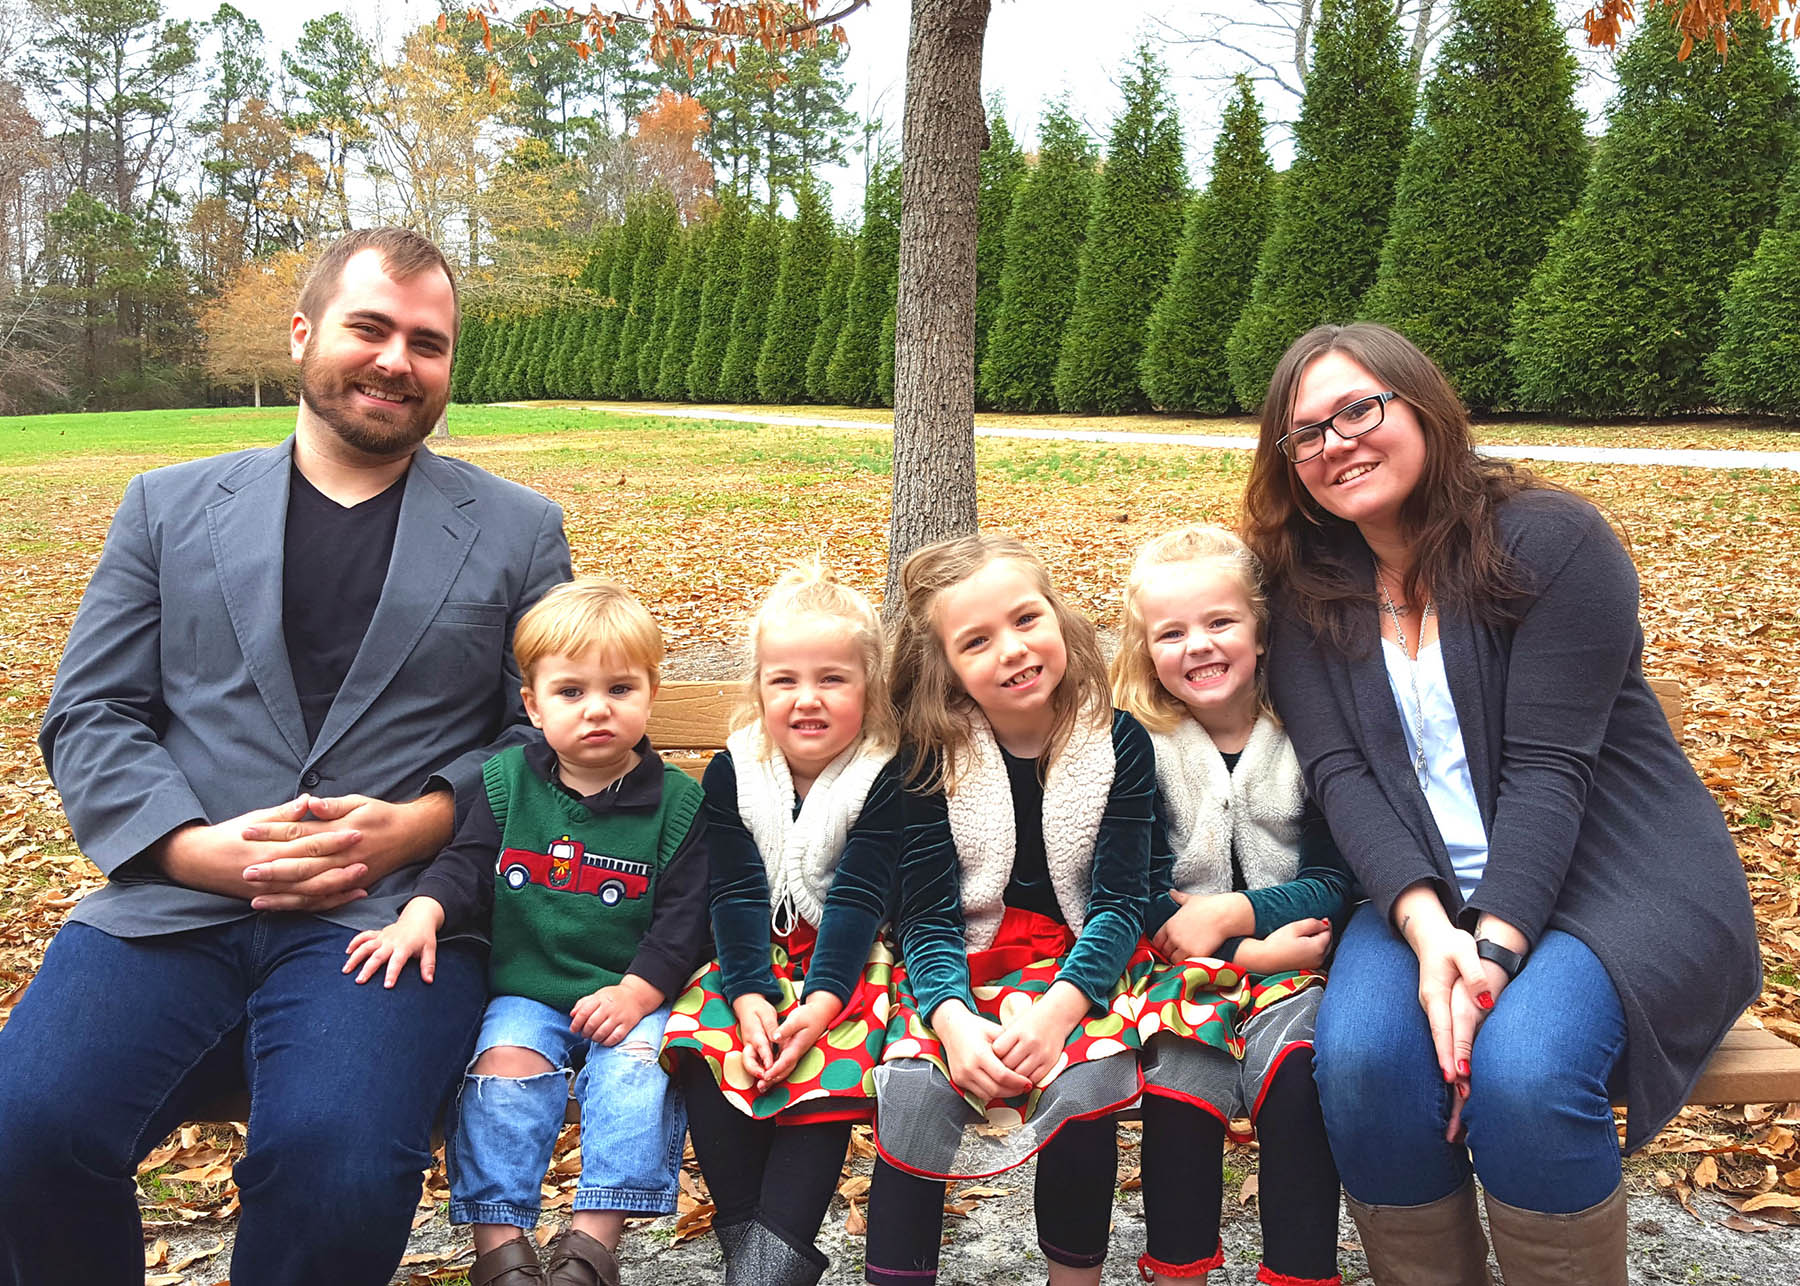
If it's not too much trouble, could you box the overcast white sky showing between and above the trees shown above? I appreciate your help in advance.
[166,0,1607,216]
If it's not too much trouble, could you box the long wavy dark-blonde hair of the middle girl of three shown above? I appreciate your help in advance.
[887,535,1111,792]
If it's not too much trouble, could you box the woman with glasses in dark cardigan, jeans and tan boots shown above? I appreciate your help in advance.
[1246,322,1760,1286]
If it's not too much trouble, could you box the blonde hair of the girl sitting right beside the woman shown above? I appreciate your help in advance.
[1112,524,1274,733]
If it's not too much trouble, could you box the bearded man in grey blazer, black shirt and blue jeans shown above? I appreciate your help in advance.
[0,229,569,1286]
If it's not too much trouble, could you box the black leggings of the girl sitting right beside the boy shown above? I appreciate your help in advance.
[677,1054,851,1246]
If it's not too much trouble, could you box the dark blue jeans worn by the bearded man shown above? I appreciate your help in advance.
[0,913,486,1286]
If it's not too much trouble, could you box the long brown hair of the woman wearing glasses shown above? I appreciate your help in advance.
[1244,322,1555,652]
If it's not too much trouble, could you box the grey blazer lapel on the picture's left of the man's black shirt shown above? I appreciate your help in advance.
[207,438,306,762]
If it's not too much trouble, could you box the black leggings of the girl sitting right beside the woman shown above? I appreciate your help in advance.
[1143,1050,1337,1281]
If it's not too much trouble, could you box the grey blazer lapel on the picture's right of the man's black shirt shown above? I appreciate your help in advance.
[307,447,481,760]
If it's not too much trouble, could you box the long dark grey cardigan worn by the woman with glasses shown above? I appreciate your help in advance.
[1269,490,1762,1151]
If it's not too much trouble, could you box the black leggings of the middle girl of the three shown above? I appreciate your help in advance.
[866,1117,1120,1286]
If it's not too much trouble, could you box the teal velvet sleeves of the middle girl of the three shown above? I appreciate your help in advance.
[898,710,1156,1021]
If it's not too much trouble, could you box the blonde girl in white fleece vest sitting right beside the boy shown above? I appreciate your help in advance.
[664,564,900,1286]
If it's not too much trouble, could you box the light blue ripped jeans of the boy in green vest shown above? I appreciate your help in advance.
[445,996,688,1228]
